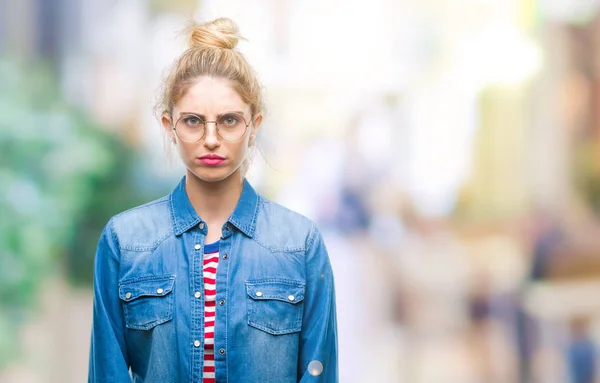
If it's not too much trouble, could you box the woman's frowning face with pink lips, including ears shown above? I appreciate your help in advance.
[162,77,262,182]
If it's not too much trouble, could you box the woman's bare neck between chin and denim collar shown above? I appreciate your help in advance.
[185,170,244,223]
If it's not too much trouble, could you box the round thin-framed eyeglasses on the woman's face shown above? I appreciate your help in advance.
[173,113,250,142]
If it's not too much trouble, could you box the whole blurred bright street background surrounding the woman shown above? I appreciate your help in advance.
[0,0,600,383]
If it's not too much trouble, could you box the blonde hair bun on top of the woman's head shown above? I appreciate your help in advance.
[189,17,240,49]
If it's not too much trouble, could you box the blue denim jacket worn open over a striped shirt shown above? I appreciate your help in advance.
[89,177,338,383]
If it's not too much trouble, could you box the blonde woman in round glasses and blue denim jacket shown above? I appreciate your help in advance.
[89,18,338,383]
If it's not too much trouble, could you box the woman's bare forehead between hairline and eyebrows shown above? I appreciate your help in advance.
[175,76,248,115]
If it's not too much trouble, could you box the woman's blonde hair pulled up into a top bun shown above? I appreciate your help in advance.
[156,18,264,174]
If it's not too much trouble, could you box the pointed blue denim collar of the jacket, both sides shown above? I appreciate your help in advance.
[169,176,260,237]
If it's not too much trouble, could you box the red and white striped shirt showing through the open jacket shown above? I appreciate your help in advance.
[202,241,219,383]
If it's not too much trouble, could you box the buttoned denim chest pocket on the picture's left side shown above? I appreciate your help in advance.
[119,276,175,330]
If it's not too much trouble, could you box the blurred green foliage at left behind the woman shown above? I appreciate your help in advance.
[0,60,148,369]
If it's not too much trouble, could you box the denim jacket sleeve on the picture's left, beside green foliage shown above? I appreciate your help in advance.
[88,221,131,383]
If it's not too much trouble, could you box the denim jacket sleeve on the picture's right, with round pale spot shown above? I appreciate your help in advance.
[298,226,338,383]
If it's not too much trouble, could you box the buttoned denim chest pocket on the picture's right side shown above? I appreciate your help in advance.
[246,279,304,335]
